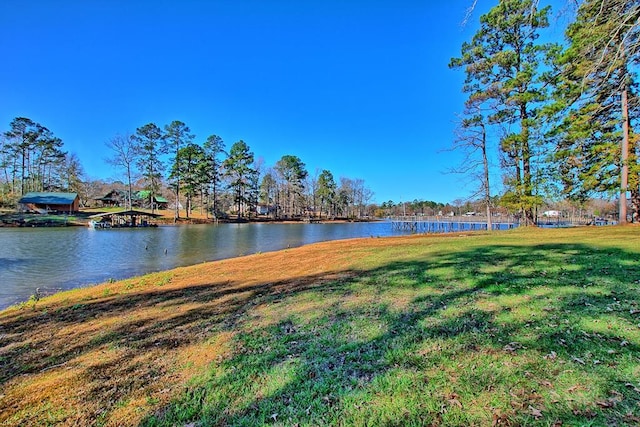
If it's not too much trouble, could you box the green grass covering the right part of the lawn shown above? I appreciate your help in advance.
[143,228,640,426]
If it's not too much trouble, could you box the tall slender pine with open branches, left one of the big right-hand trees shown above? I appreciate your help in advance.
[450,0,554,223]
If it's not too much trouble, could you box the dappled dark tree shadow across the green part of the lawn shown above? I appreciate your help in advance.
[143,244,640,425]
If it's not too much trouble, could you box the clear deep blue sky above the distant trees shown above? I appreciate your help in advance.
[0,0,564,203]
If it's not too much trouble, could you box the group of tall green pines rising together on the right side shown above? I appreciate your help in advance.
[450,0,640,224]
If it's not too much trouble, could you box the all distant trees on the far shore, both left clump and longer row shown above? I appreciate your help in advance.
[0,117,375,219]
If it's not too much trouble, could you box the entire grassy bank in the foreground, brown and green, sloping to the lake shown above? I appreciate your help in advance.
[0,227,640,426]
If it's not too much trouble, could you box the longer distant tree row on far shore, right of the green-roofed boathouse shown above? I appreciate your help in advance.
[107,121,373,219]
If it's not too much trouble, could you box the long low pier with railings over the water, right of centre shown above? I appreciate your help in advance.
[389,215,520,233]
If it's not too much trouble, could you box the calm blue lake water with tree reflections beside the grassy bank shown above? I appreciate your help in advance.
[0,222,406,309]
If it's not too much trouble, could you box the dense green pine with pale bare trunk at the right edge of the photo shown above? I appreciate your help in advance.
[549,0,640,219]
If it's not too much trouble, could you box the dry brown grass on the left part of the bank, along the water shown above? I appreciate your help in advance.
[0,238,422,425]
